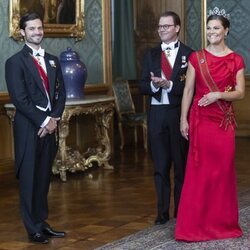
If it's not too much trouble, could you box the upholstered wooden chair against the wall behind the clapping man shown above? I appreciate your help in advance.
[112,79,147,151]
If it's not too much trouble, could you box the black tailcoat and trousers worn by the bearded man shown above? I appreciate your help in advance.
[5,45,66,233]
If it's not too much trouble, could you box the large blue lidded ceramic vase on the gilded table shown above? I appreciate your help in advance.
[60,48,87,100]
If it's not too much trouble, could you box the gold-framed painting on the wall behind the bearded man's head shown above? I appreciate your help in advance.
[9,0,85,40]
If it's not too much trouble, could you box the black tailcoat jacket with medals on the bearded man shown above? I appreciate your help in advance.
[6,45,66,176]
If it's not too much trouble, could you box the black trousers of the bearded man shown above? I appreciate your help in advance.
[19,134,56,234]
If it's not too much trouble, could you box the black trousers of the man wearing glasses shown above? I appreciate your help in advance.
[148,105,188,218]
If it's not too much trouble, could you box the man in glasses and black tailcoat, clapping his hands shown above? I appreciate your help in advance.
[140,11,192,225]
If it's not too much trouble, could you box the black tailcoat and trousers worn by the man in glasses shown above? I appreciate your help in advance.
[140,42,192,219]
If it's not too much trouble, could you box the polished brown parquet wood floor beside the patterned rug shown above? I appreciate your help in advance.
[0,138,250,250]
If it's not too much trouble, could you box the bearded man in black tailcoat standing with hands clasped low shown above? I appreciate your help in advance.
[5,13,66,244]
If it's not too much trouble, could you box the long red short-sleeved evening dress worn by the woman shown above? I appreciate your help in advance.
[175,50,245,241]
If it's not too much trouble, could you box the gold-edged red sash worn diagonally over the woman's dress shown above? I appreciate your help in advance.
[196,50,237,130]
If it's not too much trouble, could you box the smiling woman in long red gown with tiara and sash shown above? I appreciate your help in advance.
[175,10,245,241]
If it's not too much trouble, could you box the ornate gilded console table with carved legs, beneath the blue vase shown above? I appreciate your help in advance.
[5,95,114,181]
